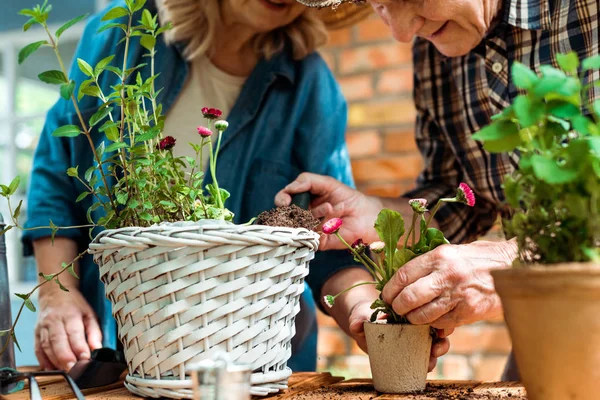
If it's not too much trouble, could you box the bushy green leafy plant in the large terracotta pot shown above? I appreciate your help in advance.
[474,53,600,400]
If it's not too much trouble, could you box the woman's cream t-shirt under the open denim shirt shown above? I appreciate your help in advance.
[163,56,246,170]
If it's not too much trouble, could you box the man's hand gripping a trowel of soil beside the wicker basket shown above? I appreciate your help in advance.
[275,172,383,250]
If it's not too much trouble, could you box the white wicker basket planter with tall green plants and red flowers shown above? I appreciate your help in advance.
[0,0,319,398]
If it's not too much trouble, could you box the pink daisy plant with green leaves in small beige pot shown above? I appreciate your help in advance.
[323,183,475,393]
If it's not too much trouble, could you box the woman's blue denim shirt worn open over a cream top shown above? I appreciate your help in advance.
[23,2,354,370]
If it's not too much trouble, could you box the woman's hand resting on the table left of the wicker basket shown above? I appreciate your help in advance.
[35,288,102,371]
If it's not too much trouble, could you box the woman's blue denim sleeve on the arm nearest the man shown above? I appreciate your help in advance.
[296,56,364,312]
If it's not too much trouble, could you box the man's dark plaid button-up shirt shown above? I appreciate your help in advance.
[405,0,600,243]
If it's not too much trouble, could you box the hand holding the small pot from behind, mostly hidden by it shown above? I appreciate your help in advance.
[349,301,454,372]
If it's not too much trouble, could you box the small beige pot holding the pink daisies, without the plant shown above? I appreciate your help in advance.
[365,322,431,393]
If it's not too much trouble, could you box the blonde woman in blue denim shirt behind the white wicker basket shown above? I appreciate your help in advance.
[23,0,380,370]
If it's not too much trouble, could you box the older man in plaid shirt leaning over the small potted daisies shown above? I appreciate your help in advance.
[282,0,600,379]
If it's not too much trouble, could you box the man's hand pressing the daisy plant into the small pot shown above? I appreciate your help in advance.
[382,241,516,329]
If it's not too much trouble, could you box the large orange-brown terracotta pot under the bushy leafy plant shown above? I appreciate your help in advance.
[492,263,600,400]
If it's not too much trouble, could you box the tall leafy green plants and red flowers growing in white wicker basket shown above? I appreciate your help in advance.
[0,0,233,354]
